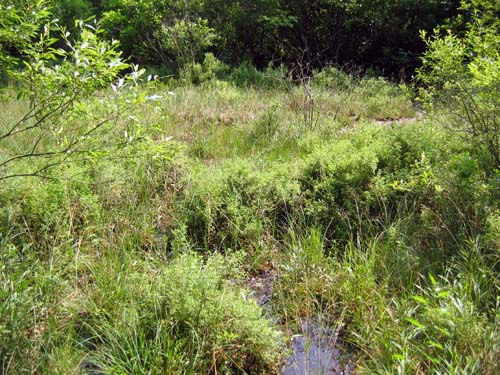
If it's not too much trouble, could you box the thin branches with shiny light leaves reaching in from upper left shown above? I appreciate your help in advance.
[0,1,145,180]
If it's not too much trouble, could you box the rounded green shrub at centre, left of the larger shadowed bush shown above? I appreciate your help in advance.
[172,160,298,250]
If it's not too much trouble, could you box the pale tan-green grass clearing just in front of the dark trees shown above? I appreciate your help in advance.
[133,79,415,160]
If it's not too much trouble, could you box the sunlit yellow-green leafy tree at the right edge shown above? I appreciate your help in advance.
[418,0,500,167]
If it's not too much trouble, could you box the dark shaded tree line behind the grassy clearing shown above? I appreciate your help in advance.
[54,0,459,77]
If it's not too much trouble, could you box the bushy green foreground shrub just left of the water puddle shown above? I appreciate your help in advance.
[86,254,282,374]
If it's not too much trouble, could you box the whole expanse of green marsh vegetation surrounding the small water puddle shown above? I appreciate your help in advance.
[0,72,500,374]
